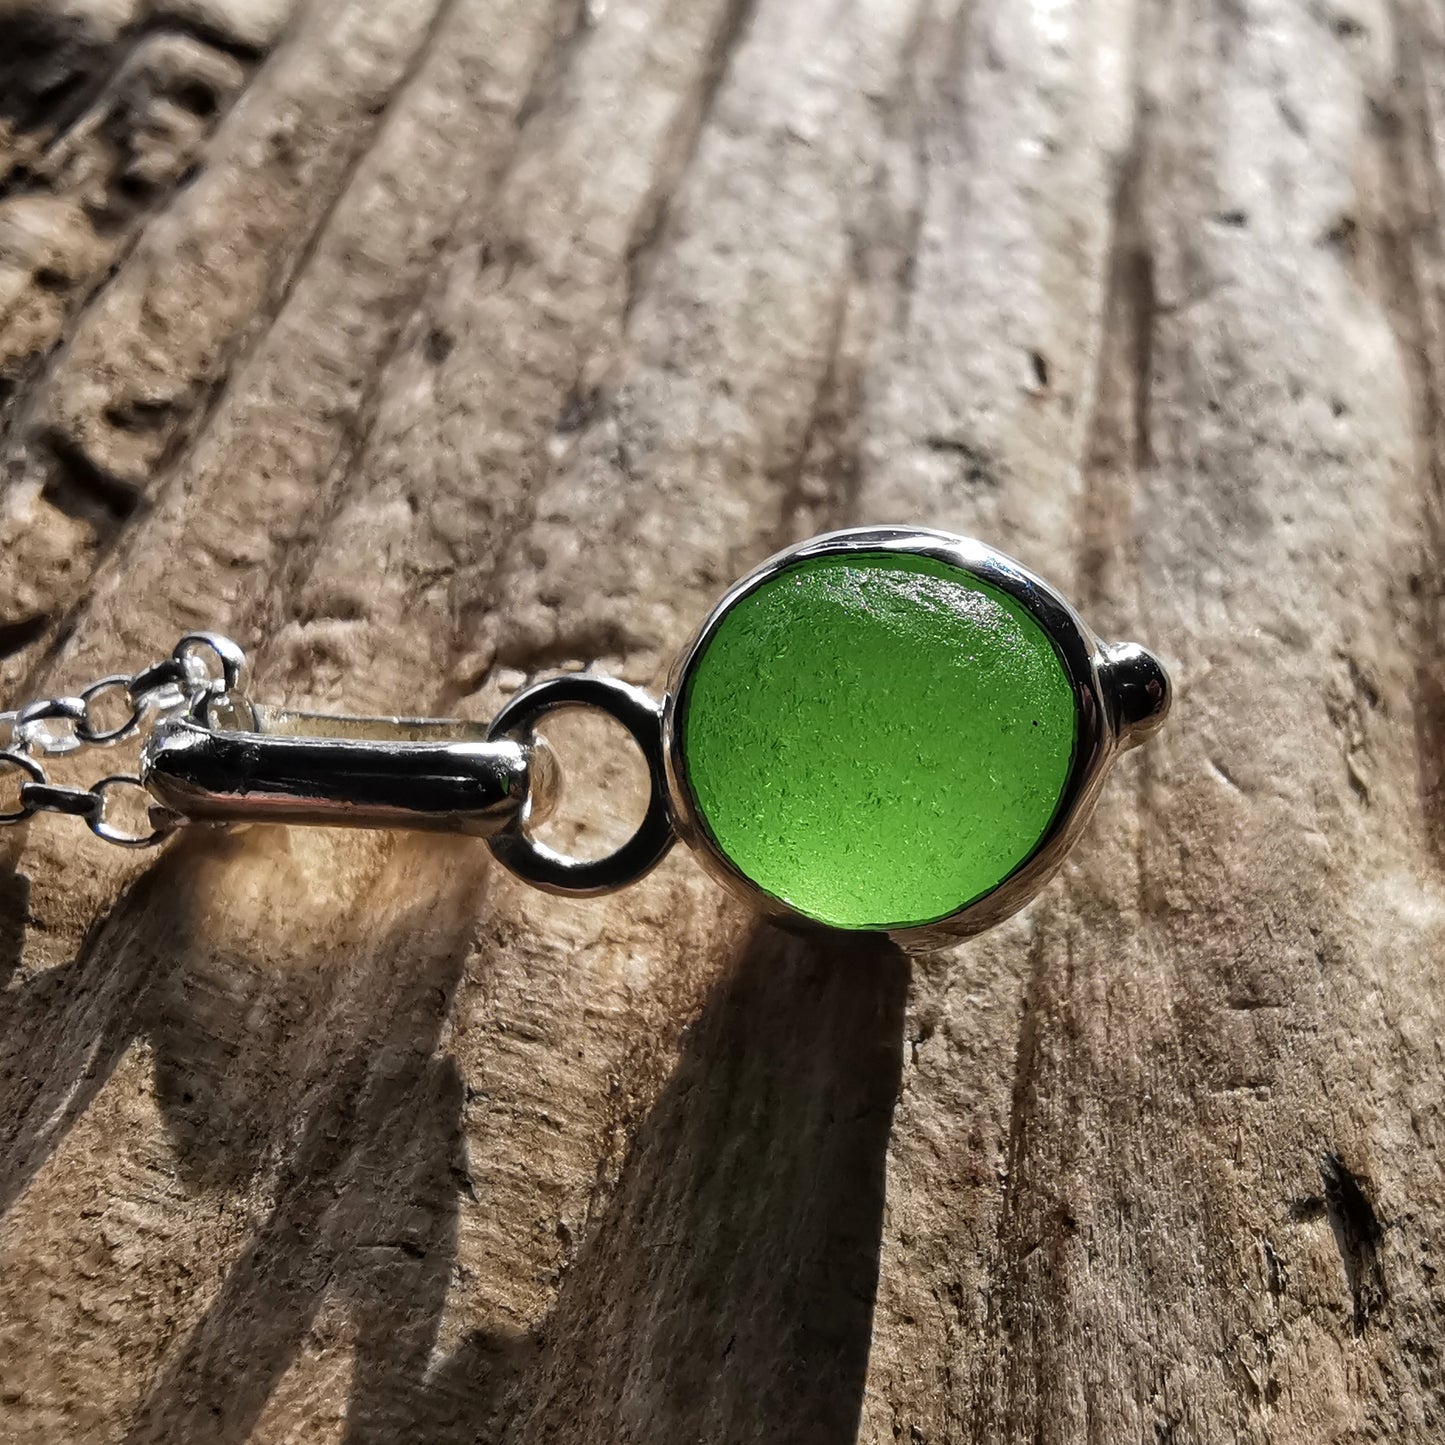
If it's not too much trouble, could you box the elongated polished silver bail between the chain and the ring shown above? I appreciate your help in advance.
[140,702,556,837]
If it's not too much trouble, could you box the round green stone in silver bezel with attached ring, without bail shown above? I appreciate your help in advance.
[479,527,1170,948]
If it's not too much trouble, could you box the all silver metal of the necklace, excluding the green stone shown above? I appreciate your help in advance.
[0,527,1170,948]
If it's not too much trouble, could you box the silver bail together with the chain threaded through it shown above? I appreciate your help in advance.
[0,631,558,848]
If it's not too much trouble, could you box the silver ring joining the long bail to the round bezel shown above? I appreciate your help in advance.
[487,673,675,896]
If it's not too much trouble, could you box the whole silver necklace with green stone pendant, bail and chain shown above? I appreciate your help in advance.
[0,527,1170,948]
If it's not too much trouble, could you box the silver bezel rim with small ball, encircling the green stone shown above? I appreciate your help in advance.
[662,527,1169,949]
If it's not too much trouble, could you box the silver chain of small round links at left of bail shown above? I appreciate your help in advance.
[0,631,246,848]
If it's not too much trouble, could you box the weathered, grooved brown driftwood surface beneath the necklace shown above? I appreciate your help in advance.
[0,0,1445,1445]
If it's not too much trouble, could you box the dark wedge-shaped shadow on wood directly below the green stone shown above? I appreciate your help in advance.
[445,928,907,1445]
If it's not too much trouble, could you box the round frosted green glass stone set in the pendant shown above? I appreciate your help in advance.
[681,552,1077,929]
